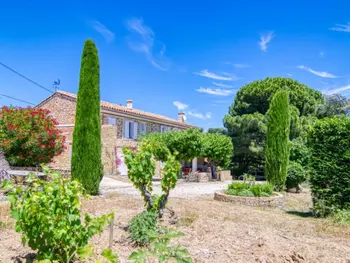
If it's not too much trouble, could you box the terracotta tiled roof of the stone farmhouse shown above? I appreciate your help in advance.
[46,90,195,127]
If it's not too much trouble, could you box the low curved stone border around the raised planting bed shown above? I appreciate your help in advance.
[214,191,284,207]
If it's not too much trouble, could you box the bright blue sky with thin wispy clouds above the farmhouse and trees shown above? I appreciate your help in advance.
[0,0,350,128]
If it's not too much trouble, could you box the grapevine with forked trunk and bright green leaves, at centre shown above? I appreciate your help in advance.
[123,139,180,217]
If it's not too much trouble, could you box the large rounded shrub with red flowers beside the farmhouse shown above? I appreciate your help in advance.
[0,107,65,166]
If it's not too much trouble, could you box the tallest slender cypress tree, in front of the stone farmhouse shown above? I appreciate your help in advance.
[71,40,103,195]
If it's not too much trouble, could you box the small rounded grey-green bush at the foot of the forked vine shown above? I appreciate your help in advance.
[129,211,158,246]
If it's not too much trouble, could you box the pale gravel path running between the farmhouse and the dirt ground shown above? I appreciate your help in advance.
[100,176,232,198]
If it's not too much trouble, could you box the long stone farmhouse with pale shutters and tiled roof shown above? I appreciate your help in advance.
[36,91,198,176]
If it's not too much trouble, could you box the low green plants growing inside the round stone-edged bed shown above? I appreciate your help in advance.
[225,182,273,197]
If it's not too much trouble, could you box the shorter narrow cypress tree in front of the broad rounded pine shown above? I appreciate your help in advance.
[265,90,290,191]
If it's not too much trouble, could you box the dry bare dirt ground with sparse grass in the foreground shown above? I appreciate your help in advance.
[0,192,350,263]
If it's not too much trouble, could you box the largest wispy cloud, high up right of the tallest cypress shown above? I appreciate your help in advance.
[126,18,170,71]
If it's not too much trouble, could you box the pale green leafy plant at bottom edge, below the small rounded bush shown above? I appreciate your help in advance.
[129,228,192,263]
